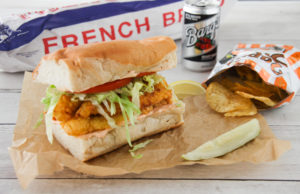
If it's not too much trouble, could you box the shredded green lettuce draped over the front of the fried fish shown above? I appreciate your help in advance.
[72,74,164,150]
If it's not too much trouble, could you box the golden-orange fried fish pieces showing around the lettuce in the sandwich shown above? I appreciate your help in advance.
[53,83,172,136]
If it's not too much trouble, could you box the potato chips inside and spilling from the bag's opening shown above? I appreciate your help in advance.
[208,66,288,113]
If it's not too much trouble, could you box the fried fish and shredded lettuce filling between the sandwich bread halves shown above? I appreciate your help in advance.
[42,74,175,145]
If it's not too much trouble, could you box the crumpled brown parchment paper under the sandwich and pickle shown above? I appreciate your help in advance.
[9,72,290,187]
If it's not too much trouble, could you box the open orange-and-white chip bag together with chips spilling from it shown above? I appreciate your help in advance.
[203,44,300,116]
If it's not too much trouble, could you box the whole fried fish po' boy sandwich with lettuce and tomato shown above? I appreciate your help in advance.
[33,36,184,161]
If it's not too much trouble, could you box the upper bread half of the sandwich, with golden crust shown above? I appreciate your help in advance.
[33,36,177,92]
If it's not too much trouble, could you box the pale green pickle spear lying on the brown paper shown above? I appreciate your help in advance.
[182,119,260,160]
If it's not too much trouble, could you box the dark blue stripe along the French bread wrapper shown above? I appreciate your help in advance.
[0,0,182,51]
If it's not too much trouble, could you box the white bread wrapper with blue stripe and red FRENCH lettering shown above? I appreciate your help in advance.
[0,0,183,72]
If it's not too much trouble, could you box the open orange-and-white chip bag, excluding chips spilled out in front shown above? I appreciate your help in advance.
[204,44,300,112]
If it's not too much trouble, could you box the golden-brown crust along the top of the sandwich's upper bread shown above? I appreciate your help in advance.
[43,36,176,68]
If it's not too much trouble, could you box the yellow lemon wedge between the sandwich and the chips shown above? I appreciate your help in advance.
[170,80,205,99]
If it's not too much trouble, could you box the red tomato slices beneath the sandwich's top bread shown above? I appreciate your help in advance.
[74,72,155,94]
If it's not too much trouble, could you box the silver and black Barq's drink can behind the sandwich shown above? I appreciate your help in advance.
[181,0,220,71]
